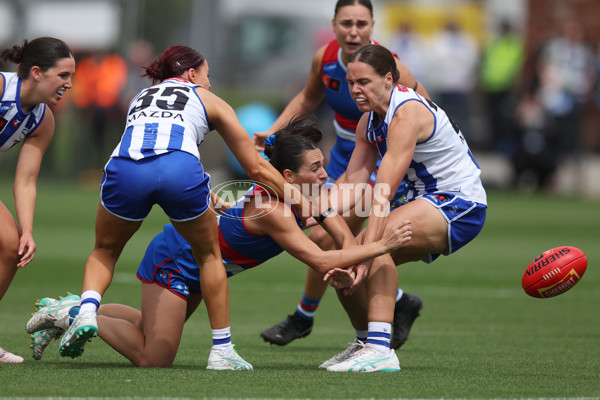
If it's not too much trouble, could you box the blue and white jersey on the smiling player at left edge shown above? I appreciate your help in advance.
[0,72,46,151]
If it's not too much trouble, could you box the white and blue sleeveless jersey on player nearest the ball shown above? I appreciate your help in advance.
[366,85,487,204]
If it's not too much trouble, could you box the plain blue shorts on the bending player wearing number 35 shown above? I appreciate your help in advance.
[100,151,210,221]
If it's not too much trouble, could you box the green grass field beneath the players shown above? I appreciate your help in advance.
[0,182,600,399]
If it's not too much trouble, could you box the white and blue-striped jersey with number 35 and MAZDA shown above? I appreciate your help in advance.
[112,78,211,160]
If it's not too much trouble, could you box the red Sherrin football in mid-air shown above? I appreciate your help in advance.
[521,246,587,298]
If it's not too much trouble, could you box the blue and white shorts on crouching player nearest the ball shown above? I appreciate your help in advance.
[419,193,487,263]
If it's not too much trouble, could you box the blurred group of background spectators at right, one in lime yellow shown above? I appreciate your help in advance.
[390,17,600,188]
